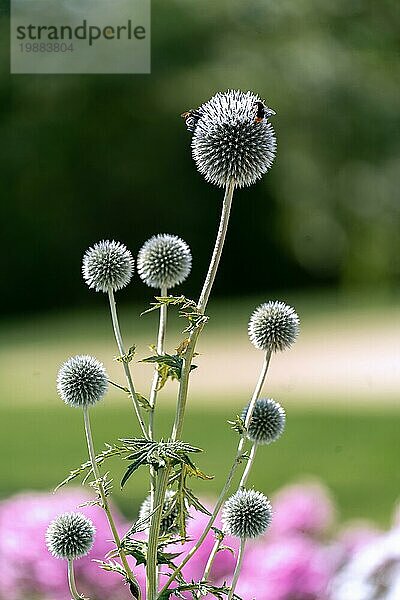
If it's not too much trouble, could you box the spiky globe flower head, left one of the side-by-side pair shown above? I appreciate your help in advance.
[82,240,134,293]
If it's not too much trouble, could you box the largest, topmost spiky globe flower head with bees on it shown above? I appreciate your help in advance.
[187,90,276,187]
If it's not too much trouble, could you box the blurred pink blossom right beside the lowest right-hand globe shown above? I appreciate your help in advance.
[267,482,336,538]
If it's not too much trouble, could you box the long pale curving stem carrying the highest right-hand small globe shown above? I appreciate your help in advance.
[161,351,271,593]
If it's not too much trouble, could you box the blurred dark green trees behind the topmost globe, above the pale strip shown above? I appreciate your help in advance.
[0,0,400,312]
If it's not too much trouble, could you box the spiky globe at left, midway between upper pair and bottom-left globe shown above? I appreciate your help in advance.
[57,354,108,408]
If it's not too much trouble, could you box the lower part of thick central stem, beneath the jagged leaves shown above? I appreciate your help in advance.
[146,467,170,600]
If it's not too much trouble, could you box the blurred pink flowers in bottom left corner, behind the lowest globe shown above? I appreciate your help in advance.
[0,490,132,600]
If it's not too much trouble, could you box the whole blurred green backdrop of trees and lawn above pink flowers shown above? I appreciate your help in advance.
[0,0,400,522]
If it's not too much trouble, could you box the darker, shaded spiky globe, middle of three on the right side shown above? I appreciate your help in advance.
[242,398,286,444]
